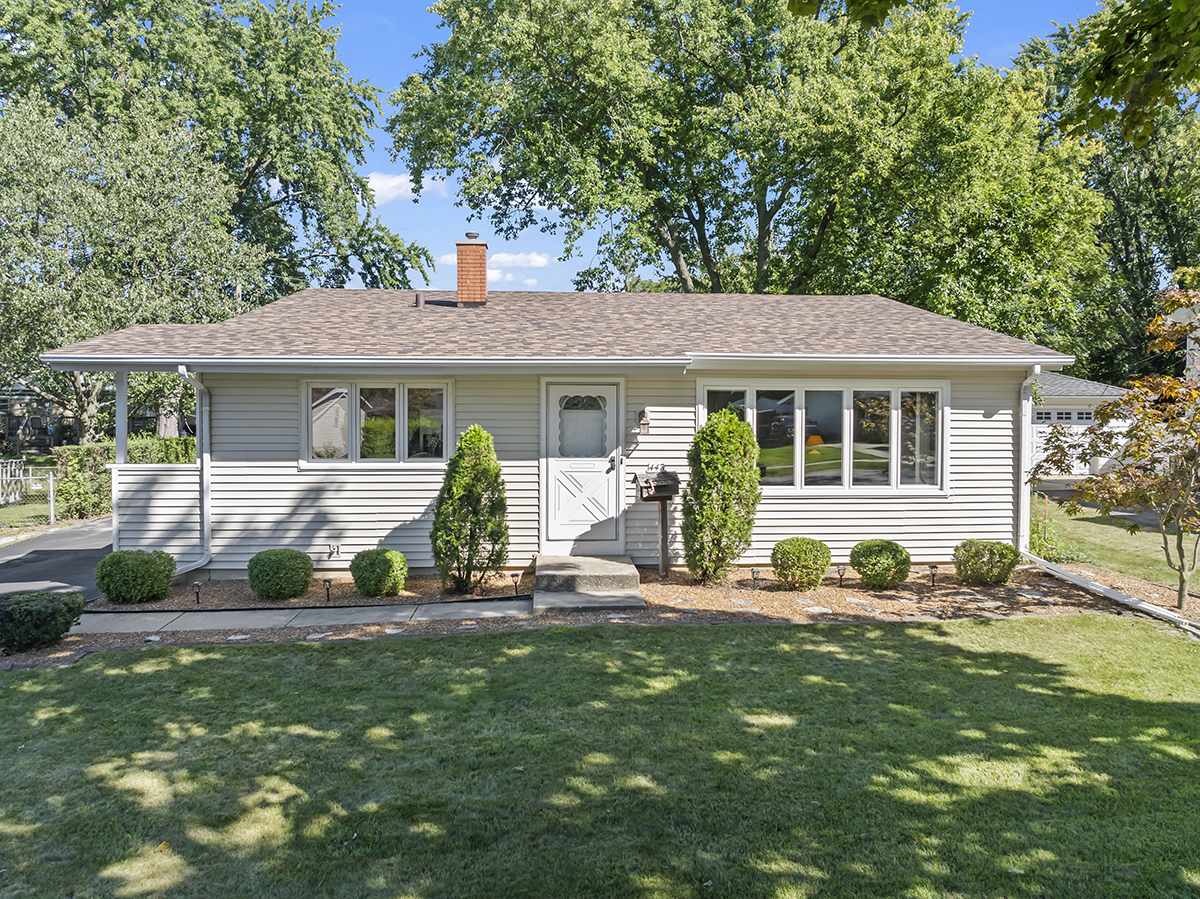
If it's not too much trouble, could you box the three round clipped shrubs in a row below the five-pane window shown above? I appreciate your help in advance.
[770,537,1021,591]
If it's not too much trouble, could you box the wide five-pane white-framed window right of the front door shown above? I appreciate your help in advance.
[701,383,944,492]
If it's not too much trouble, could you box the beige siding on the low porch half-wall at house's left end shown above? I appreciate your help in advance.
[112,465,204,563]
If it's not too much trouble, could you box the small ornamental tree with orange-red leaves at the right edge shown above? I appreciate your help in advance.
[1030,290,1200,611]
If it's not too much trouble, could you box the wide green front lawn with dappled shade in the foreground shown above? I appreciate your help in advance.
[0,615,1200,899]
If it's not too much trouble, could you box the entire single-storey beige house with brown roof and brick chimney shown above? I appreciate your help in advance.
[43,239,1073,576]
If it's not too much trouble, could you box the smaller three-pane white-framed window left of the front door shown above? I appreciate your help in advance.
[305,382,449,465]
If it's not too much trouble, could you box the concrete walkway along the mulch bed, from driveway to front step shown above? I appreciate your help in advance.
[71,599,533,634]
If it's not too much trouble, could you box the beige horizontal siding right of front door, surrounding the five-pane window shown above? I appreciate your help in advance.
[625,368,1022,564]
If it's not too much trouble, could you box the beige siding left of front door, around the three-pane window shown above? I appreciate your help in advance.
[194,374,539,571]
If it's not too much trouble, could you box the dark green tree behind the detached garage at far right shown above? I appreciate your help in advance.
[1015,21,1200,382]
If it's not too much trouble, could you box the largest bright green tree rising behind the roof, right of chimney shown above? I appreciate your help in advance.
[388,0,1102,348]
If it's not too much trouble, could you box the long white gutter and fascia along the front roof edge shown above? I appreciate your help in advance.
[41,352,1075,374]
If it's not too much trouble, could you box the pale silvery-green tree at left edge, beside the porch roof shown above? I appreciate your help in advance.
[0,100,263,442]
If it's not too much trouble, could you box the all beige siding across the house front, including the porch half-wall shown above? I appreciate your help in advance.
[112,367,1024,573]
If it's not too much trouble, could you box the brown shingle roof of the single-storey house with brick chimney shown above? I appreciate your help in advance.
[46,289,1070,365]
